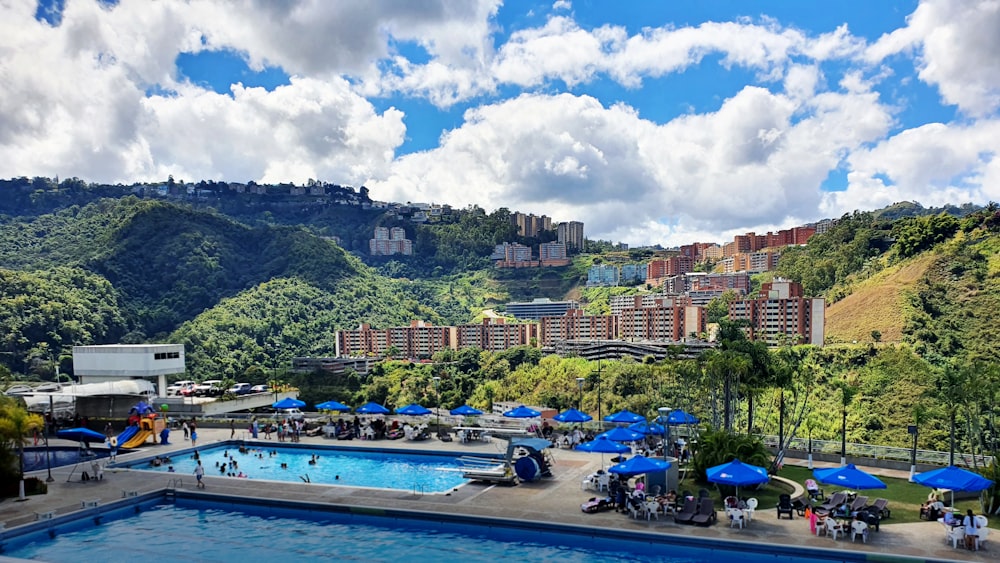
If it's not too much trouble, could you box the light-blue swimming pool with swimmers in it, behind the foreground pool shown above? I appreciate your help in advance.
[113,441,480,493]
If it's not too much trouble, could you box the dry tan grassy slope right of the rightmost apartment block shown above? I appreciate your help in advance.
[826,254,933,343]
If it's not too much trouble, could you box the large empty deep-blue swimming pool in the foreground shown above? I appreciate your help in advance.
[0,491,896,563]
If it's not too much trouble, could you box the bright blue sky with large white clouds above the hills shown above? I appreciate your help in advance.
[0,0,1000,245]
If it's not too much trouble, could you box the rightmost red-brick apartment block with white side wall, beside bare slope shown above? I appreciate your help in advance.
[729,278,826,346]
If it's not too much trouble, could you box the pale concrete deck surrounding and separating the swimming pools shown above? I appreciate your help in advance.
[0,428,1000,561]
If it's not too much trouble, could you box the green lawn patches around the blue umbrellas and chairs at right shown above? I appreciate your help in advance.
[678,465,1000,529]
